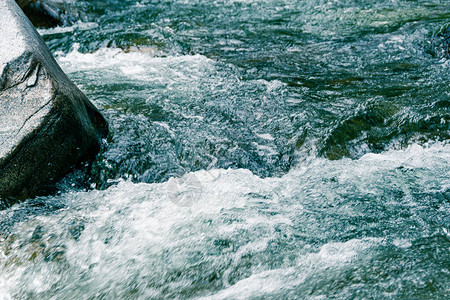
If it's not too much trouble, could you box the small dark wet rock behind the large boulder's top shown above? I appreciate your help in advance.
[16,0,75,28]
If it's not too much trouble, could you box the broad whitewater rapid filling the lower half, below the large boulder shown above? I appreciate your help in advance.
[0,144,450,299]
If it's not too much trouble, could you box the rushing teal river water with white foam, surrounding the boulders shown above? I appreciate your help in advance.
[0,0,450,299]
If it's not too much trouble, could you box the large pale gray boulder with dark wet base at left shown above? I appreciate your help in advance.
[0,0,108,204]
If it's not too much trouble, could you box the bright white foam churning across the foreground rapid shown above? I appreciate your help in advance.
[0,143,450,299]
